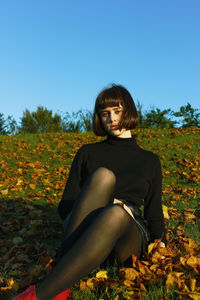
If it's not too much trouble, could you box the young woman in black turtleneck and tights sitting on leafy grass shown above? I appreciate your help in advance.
[13,85,166,300]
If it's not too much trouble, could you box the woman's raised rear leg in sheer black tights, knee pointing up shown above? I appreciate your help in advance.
[56,167,116,263]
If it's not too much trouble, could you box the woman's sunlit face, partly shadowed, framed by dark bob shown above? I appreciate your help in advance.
[100,105,130,137]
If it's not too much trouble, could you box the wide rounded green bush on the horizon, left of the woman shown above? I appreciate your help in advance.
[19,106,63,133]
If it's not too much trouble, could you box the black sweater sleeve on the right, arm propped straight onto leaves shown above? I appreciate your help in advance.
[144,155,166,243]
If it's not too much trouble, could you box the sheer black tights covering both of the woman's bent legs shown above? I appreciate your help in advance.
[36,168,142,300]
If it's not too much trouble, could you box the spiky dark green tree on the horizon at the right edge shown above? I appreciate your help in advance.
[173,102,200,128]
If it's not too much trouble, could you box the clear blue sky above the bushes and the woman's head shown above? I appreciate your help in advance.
[0,0,200,122]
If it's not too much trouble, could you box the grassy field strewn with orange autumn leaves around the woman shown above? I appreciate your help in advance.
[0,128,200,300]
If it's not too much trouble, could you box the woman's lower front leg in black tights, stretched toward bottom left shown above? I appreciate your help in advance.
[36,205,142,300]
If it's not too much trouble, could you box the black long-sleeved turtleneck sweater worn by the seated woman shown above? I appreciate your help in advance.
[58,135,166,242]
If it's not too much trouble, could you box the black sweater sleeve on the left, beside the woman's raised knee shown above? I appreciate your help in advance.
[58,146,85,219]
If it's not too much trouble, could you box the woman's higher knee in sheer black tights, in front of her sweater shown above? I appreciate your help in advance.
[91,167,116,187]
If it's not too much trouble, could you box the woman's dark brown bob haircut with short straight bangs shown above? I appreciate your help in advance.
[92,84,139,136]
